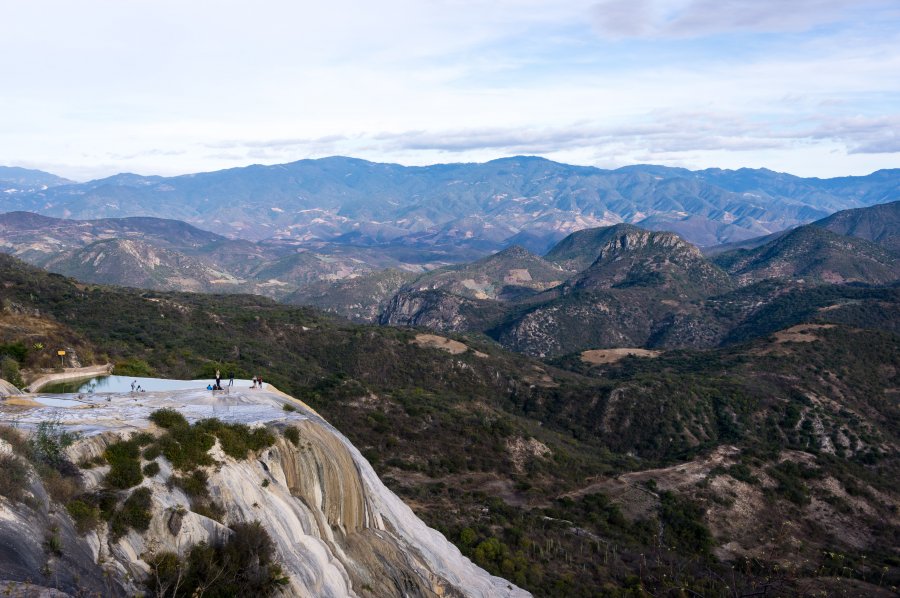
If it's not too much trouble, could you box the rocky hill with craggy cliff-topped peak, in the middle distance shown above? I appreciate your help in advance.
[379,224,732,357]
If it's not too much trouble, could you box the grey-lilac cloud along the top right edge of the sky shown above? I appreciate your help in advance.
[591,0,896,38]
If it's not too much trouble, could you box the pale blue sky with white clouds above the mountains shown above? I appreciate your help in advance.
[0,0,900,180]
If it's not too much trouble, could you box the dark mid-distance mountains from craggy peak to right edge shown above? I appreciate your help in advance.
[342,202,900,357]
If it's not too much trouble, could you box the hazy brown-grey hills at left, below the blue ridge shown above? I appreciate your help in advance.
[0,212,446,298]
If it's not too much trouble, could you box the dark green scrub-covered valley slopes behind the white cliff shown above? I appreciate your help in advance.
[0,248,900,596]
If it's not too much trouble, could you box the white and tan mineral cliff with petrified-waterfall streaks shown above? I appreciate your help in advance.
[0,389,529,598]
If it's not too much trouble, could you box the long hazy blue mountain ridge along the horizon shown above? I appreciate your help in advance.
[0,156,900,253]
